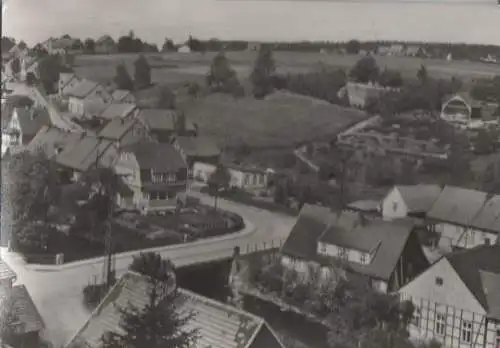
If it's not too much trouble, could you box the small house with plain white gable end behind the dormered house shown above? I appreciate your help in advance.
[380,184,443,220]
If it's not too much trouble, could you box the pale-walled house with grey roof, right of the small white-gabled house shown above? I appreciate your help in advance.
[427,186,497,251]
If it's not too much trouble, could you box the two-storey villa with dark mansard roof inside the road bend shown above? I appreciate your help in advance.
[115,141,187,213]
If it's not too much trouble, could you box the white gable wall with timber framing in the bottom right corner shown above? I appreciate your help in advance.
[399,258,496,348]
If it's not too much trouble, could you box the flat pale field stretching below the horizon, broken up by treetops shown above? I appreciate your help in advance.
[75,51,500,87]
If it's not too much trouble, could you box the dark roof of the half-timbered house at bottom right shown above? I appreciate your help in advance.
[445,245,500,320]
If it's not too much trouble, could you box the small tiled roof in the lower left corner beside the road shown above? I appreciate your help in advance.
[0,285,45,334]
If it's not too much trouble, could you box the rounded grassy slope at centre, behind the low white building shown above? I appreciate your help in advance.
[182,92,368,148]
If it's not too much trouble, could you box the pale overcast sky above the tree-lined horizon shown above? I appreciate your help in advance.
[2,0,500,45]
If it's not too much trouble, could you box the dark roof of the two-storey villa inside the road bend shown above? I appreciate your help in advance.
[122,141,187,172]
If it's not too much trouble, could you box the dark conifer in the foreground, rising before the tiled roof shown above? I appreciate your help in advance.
[101,253,198,348]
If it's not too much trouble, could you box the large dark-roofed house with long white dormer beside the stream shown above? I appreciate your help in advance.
[280,204,429,293]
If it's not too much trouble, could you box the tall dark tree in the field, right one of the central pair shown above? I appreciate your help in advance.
[250,45,276,99]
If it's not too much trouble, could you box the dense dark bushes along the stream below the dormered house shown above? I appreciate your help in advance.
[249,256,439,348]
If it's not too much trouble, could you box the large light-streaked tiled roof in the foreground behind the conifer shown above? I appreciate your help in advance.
[67,271,282,348]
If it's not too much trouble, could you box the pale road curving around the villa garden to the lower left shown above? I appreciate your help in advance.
[3,193,295,348]
